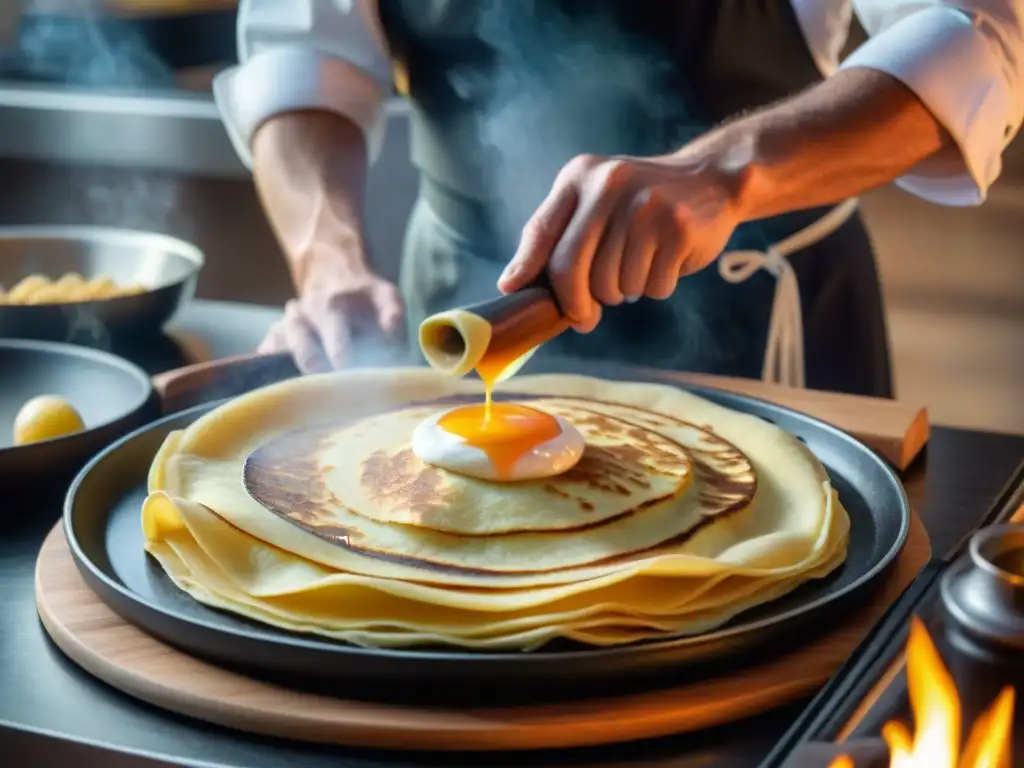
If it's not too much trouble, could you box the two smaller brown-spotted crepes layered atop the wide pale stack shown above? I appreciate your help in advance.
[234,398,757,574]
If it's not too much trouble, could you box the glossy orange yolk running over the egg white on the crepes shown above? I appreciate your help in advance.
[437,400,562,478]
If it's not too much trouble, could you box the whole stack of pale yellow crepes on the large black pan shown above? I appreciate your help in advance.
[142,369,849,650]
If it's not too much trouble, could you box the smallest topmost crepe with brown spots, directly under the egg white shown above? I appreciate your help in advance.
[296,399,692,536]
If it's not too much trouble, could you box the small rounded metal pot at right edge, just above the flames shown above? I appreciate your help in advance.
[940,524,1024,650]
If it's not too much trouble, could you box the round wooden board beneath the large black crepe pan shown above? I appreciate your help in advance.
[36,515,931,751]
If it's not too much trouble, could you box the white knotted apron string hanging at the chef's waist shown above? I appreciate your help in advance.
[718,198,858,388]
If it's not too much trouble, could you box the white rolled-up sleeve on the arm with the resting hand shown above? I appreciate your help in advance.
[213,0,391,166]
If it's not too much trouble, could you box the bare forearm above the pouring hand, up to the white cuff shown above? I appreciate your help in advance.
[681,69,949,219]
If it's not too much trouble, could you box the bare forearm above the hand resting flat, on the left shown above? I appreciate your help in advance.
[252,111,367,290]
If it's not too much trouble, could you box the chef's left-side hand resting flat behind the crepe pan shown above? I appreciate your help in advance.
[259,254,403,373]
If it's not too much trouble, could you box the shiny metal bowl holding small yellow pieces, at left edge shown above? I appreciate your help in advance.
[0,226,203,345]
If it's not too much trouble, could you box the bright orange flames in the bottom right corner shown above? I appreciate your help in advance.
[829,616,1014,768]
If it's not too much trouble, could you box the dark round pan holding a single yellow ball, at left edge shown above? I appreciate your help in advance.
[0,339,160,501]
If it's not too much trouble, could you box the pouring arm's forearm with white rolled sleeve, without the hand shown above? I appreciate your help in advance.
[681,0,1024,218]
